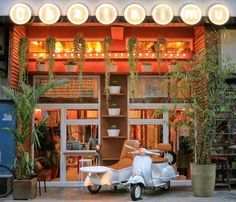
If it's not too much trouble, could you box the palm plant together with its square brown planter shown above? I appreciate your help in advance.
[1,80,65,199]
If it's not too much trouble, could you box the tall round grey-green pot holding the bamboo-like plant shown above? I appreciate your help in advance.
[190,163,216,197]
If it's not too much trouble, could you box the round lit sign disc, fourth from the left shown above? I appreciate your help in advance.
[95,3,117,25]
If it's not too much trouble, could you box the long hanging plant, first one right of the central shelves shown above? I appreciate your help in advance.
[128,37,139,98]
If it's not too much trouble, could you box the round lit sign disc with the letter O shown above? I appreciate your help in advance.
[10,3,32,25]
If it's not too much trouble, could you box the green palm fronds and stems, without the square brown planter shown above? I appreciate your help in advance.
[1,80,66,179]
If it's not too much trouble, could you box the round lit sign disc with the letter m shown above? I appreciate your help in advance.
[180,4,202,25]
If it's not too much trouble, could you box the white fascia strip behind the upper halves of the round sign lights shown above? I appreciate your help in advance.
[0,0,236,16]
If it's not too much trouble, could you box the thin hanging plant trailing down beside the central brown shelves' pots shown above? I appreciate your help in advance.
[103,36,112,108]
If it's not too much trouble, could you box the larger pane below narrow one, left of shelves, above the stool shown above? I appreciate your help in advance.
[66,125,98,150]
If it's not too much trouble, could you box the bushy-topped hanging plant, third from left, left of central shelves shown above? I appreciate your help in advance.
[73,33,86,98]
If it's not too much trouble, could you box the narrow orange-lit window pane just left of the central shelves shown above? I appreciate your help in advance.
[66,109,98,120]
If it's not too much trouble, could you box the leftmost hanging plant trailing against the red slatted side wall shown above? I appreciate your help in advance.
[18,37,29,83]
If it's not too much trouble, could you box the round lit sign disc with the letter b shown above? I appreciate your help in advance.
[39,3,60,25]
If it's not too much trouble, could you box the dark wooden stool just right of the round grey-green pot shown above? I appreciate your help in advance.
[211,156,231,191]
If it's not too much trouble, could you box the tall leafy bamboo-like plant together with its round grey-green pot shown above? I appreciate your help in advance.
[169,48,231,197]
